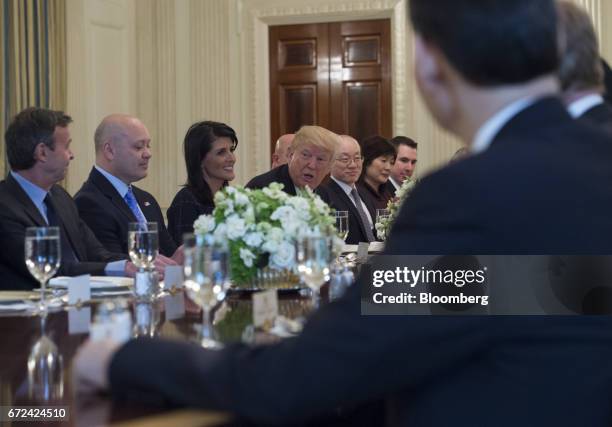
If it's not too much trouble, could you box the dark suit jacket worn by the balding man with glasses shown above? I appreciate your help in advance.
[315,178,376,245]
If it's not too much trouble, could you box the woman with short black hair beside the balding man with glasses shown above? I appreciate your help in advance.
[357,136,397,219]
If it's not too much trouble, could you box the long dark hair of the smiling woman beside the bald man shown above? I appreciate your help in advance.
[183,121,238,205]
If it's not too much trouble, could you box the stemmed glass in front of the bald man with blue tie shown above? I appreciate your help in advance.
[128,222,159,299]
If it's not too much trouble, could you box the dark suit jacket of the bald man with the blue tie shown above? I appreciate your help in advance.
[74,168,176,256]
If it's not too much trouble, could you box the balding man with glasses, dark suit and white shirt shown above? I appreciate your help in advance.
[316,135,376,245]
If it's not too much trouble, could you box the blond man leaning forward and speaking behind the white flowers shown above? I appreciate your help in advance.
[246,126,339,196]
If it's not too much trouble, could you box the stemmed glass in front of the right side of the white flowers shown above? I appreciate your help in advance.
[300,236,331,309]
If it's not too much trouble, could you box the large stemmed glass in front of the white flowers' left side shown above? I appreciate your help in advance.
[183,234,229,348]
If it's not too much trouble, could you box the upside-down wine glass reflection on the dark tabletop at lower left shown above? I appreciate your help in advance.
[27,316,64,402]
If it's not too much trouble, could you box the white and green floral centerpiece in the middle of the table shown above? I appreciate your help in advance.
[194,183,335,287]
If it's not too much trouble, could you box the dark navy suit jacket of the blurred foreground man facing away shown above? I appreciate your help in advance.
[110,98,612,427]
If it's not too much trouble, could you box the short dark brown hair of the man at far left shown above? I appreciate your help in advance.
[4,107,72,171]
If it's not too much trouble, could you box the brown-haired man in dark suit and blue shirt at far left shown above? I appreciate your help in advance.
[0,108,135,289]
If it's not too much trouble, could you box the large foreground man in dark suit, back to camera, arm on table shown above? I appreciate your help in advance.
[76,0,612,427]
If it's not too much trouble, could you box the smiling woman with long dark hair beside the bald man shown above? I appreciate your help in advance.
[168,121,238,244]
